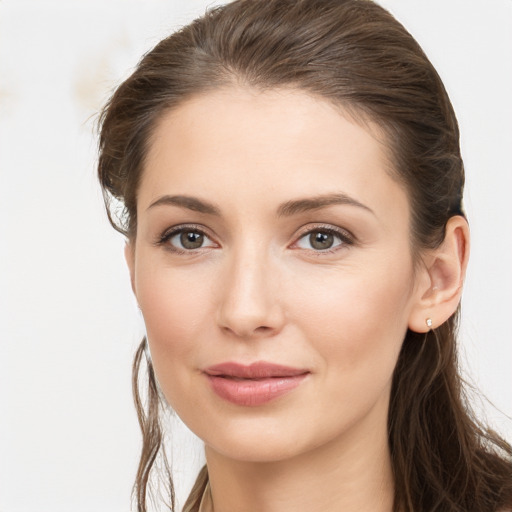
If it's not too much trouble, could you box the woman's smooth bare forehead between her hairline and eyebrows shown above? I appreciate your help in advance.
[139,87,407,221]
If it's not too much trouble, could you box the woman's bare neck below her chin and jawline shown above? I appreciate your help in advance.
[202,404,394,512]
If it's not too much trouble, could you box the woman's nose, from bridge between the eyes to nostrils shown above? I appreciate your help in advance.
[217,250,285,339]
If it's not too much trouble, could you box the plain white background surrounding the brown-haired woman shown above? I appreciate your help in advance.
[0,0,512,512]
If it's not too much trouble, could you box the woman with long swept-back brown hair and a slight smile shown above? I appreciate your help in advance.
[99,0,512,512]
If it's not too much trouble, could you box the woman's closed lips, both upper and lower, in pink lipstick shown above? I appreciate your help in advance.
[204,361,309,407]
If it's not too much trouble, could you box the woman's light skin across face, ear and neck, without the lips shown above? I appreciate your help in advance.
[126,87,468,512]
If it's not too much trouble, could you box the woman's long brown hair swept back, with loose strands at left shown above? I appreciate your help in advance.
[98,0,512,512]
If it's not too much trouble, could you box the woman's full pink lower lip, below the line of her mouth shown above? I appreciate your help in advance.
[207,373,308,407]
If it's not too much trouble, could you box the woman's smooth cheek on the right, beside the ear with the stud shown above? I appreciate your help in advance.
[295,265,412,379]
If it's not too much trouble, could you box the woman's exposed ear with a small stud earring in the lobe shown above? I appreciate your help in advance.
[409,215,469,332]
